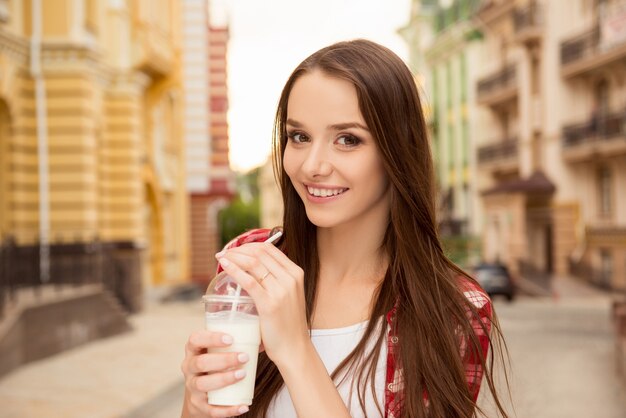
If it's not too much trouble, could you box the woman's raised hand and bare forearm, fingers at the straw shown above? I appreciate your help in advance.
[216,243,350,418]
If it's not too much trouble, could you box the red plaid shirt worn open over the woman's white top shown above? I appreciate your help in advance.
[218,229,492,418]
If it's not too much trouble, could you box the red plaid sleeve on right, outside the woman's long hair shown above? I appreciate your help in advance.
[460,283,492,402]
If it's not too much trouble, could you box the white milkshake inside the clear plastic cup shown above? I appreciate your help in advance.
[206,311,261,405]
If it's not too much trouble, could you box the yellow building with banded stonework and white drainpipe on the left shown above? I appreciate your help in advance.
[0,0,189,310]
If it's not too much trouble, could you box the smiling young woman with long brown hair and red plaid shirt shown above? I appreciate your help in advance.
[182,40,506,418]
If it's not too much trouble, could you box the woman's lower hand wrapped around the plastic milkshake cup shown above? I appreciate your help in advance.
[181,331,248,418]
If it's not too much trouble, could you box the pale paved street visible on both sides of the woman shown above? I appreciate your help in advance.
[0,282,626,418]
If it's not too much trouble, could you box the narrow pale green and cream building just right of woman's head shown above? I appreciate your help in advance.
[401,0,482,266]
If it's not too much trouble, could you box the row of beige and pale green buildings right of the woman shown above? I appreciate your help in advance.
[401,0,626,289]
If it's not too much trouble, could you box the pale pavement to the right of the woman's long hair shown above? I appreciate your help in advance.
[481,297,626,418]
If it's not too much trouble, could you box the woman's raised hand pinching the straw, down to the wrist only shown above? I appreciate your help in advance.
[216,243,311,368]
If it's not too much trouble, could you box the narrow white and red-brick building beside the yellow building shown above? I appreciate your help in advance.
[184,0,235,286]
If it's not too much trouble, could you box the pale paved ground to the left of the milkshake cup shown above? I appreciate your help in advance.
[0,300,203,418]
